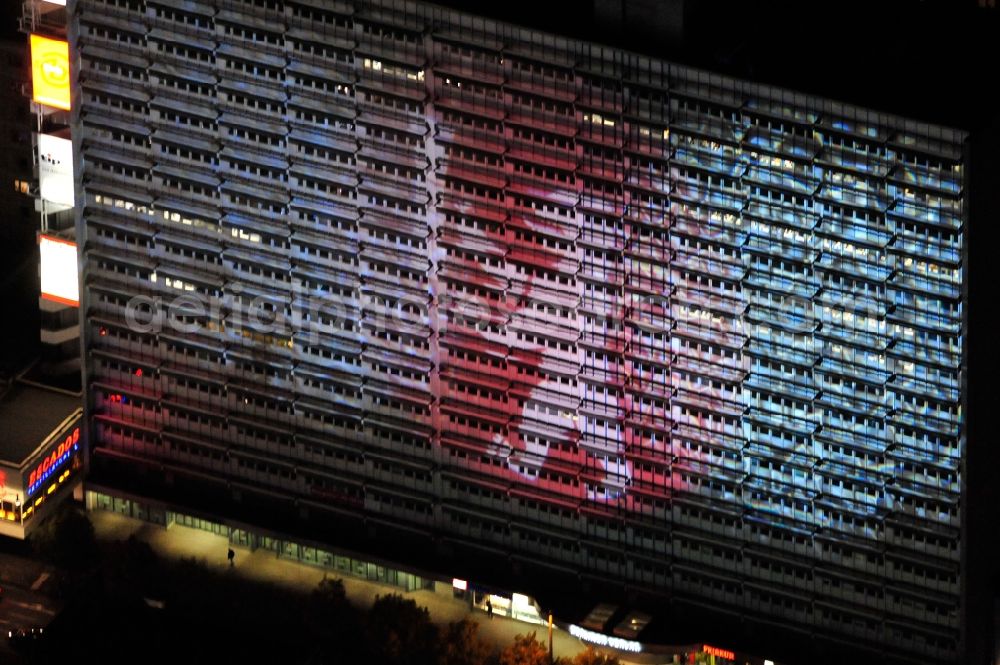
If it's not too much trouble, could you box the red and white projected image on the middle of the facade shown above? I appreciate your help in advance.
[426,65,692,510]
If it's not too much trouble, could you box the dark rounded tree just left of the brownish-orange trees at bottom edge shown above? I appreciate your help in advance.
[365,594,439,665]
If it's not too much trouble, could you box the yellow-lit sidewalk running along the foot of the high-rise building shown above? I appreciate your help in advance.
[88,511,585,657]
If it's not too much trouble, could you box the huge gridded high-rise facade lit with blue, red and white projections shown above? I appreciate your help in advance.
[76,0,966,661]
